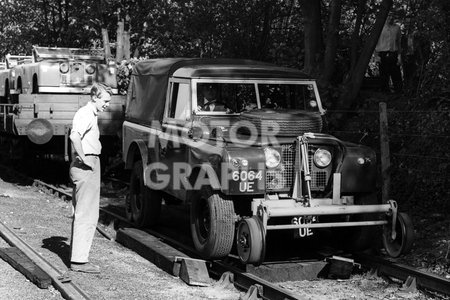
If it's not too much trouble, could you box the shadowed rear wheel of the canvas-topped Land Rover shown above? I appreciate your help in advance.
[125,161,162,227]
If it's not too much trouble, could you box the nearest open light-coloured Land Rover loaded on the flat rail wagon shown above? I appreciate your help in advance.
[10,46,117,94]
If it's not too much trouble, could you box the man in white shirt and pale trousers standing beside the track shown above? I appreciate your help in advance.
[70,83,111,273]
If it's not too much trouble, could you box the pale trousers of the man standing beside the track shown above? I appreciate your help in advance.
[70,156,100,263]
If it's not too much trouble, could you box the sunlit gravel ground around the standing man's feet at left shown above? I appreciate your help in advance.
[0,176,240,300]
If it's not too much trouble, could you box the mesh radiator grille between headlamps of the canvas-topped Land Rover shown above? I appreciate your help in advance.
[266,144,329,191]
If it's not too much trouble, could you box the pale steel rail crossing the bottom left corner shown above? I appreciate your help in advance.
[0,220,90,300]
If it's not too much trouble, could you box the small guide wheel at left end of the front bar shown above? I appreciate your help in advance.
[236,216,266,265]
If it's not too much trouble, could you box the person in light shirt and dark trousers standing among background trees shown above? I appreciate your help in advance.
[375,15,403,92]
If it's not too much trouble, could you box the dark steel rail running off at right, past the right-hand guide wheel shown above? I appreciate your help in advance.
[354,253,450,296]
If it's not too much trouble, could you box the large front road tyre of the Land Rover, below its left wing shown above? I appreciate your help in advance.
[190,188,235,259]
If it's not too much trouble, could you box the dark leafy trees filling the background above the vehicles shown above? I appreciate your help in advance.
[0,0,450,209]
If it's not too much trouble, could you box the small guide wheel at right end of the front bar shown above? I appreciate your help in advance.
[383,212,414,257]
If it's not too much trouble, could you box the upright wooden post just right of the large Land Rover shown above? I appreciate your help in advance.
[379,102,391,203]
